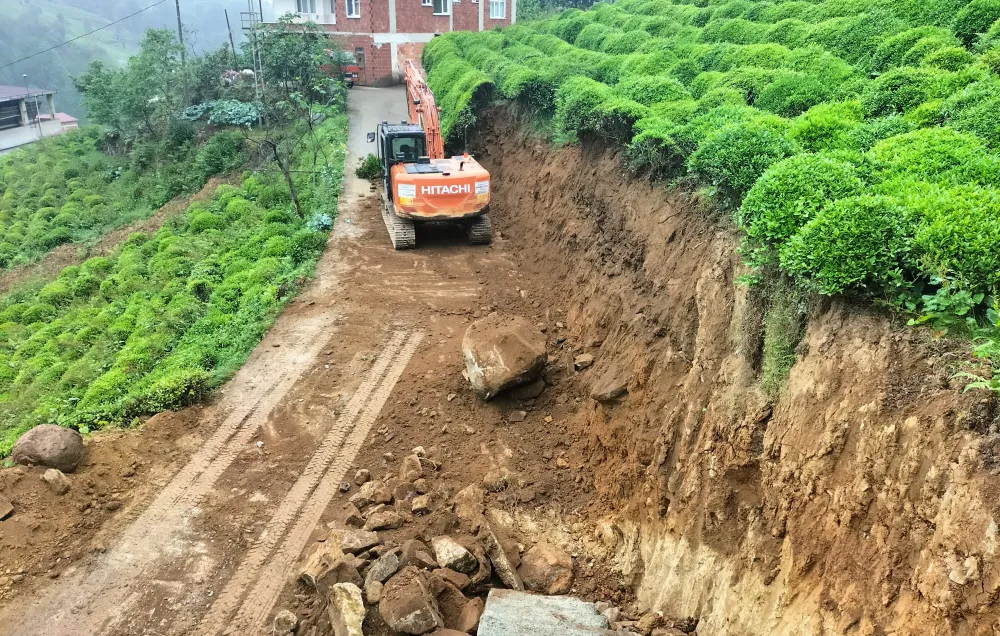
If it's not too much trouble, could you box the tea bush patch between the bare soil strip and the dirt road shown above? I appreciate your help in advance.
[0,114,347,455]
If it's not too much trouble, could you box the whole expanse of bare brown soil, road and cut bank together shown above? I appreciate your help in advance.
[0,103,1000,636]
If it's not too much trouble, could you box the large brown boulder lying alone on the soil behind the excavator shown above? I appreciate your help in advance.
[462,314,547,400]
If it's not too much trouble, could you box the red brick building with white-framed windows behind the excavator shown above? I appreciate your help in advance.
[273,0,517,86]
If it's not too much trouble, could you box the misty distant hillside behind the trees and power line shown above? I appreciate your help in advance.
[0,0,258,119]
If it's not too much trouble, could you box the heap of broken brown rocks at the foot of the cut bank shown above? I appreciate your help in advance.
[286,448,573,636]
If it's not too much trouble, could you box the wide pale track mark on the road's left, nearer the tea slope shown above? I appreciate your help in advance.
[10,338,332,636]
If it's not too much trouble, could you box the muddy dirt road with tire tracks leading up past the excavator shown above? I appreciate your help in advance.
[0,87,532,636]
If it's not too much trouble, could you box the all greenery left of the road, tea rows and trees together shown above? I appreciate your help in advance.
[0,25,347,456]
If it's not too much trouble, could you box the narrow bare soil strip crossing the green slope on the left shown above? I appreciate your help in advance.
[0,177,234,294]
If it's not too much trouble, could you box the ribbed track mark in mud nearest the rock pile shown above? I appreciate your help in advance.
[197,332,423,636]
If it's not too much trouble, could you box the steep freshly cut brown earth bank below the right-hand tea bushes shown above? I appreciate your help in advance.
[474,111,1000,635]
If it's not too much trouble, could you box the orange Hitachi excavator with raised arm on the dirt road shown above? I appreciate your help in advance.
[368,61,493,250]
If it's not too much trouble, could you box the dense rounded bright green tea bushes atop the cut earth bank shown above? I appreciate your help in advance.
[424,0,1000,382]
